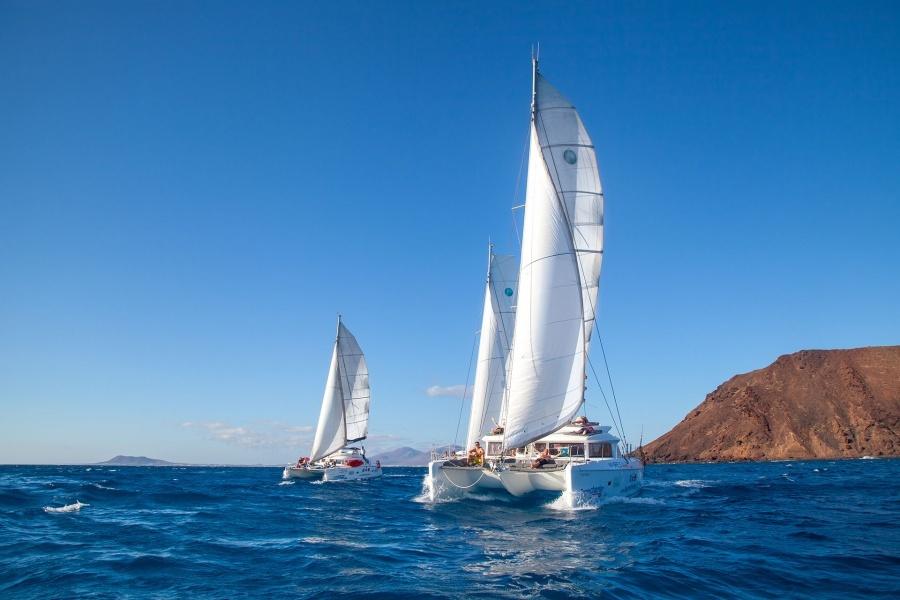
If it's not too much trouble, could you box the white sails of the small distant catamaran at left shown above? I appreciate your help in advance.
[309,317,370,461]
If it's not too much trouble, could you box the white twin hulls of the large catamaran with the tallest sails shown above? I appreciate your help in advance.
[426,459,644,502]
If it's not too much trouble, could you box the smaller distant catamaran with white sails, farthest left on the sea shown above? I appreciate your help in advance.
[282,315,381,481]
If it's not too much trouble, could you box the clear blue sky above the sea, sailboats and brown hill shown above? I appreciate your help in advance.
[0,0,900,463]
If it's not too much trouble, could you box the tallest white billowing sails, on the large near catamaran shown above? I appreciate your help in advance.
[505,63,603,448]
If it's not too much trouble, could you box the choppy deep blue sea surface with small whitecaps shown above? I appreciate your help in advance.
[0,459,900,598]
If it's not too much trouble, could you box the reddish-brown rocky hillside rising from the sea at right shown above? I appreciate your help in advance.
[644,346,900,462]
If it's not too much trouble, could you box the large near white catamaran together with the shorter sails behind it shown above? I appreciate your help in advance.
[426,59,644,500]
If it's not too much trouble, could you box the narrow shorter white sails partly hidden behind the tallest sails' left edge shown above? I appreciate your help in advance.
[466,253,518,448]
